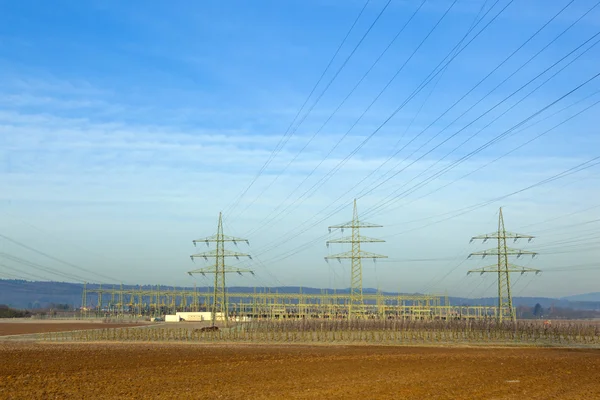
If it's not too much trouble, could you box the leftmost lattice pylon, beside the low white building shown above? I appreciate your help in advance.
[188,213,254,326]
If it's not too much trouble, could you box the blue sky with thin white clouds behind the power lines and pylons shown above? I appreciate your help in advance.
[0,0,600,297]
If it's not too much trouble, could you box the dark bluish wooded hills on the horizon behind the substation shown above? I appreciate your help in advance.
[0,279,600,310]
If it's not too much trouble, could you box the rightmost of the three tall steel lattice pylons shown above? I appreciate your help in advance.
[467,207,541,323]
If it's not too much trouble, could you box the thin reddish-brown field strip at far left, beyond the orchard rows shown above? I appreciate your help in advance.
[0,321,149,336]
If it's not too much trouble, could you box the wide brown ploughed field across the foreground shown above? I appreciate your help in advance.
[0,342,600,400]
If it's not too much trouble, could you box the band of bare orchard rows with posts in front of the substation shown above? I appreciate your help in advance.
[38,320,600,345]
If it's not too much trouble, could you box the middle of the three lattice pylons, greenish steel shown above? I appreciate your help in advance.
[325,199,387,319]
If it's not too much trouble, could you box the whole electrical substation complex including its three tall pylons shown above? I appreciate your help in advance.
[82,200,541,325]
